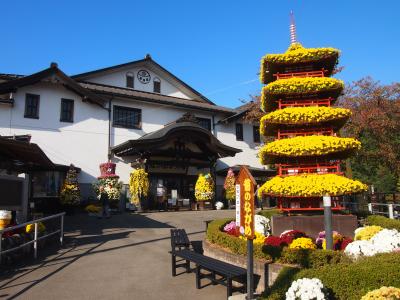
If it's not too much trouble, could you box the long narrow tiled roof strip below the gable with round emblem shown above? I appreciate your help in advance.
[80,82,236,114]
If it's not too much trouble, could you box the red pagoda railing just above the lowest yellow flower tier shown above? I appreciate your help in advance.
[277,162,343,176]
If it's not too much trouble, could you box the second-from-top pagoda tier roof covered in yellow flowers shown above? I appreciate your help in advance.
[261,77,344,112]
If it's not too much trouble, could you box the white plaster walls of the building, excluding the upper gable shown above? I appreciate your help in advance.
[0,83,262,195]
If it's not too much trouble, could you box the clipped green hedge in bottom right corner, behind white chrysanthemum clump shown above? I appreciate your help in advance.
[264,253,400,300]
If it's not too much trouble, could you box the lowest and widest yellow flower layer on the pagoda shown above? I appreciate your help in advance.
[258,174,367,197]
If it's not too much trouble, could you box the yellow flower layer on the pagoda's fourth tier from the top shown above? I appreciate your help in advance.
[259,135,361,161]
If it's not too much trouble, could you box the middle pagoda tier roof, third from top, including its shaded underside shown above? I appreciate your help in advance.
[260,106,351,136]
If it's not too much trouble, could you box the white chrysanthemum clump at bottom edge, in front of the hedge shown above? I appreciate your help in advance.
[286,278,326,300]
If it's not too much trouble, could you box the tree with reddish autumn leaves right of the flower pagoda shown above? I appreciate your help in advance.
[338,77,400,192]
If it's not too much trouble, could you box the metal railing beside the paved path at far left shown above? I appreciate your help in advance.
[0,212,65,263]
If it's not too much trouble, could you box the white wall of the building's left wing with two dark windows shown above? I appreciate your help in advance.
[0,83,108,183]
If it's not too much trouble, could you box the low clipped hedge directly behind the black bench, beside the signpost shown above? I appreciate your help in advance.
[207,219,272,261]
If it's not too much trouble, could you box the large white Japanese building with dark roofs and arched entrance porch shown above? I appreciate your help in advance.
[0,55,274,207]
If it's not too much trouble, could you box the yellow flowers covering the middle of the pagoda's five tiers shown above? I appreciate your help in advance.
[260,106,351,135]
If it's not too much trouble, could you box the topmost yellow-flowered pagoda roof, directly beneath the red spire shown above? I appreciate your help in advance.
[260,43,340,84]
